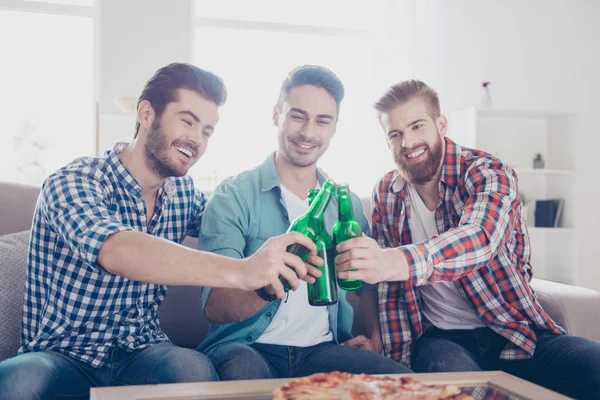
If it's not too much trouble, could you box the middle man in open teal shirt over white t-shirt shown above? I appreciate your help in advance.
[199,65,409,380]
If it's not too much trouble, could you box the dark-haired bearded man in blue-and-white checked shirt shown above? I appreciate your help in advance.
[0,63,316,399]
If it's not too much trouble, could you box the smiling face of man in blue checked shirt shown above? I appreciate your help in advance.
[144,89,218,179]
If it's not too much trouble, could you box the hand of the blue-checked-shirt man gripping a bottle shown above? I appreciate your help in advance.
[238,232,324,298]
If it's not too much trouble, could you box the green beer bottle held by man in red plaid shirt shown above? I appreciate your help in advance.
[333,184,365,290]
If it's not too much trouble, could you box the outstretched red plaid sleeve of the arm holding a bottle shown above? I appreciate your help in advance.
[400,160,519,285]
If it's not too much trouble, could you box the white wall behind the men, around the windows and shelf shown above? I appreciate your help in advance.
[99,0,600,290]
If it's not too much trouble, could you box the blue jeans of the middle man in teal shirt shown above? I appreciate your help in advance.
[207,342,412,380]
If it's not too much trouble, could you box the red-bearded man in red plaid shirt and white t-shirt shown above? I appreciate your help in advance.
[336,81,600,399]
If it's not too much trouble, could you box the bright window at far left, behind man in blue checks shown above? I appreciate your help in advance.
[0,0,95,185]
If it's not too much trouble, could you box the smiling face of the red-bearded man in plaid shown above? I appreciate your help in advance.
[381,97,447,185]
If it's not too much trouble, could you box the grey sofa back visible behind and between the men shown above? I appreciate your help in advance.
[0,182,366,361]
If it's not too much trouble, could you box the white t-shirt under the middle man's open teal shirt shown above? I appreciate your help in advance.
[256,185,333,347]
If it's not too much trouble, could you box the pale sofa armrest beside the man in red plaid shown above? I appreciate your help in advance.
[531,279,600,340]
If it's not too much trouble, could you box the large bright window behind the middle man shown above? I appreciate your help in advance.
[191,0,391,196]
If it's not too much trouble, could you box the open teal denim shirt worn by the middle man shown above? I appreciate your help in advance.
[198,153,371,353]
